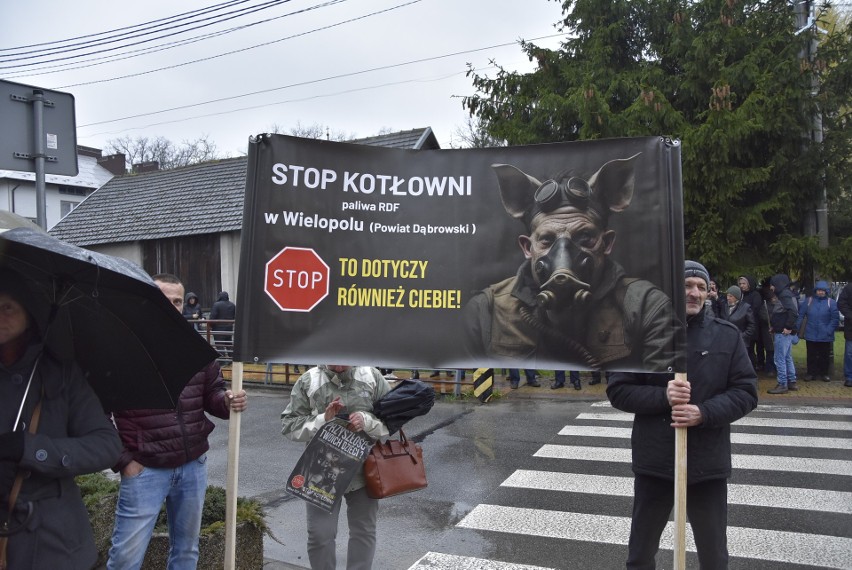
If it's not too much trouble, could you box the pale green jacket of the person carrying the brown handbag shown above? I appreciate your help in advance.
[281,365,390,493]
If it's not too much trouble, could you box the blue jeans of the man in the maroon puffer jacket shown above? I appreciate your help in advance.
[107,455,207,570]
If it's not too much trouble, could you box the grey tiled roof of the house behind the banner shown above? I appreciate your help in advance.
[50,127,440,246]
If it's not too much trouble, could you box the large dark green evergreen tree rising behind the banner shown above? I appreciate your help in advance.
[465,0,852,276]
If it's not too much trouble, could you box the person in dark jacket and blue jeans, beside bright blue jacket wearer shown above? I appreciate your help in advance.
[768,273,799,394]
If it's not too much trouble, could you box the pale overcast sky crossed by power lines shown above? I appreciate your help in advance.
[0,0,561,156]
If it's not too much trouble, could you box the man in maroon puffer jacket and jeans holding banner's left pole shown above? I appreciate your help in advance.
[107,274,246,570]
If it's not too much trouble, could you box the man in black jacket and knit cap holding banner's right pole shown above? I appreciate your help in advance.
[607,261,757,570]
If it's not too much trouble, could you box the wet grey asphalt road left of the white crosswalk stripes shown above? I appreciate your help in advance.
[208,387,604,569]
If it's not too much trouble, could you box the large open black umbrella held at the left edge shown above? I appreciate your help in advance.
[0,228,218,411]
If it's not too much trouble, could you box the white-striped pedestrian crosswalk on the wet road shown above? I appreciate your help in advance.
[409,402,852,570]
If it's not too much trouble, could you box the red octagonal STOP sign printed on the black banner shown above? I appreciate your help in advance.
[263,247,329,312]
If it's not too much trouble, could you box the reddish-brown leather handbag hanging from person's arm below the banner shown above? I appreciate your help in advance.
[364,429,428,499]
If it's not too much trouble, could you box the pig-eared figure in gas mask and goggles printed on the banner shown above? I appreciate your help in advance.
[465,155,675,372]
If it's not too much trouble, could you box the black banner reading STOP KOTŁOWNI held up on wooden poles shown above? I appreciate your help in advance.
[235,135,685,371]
